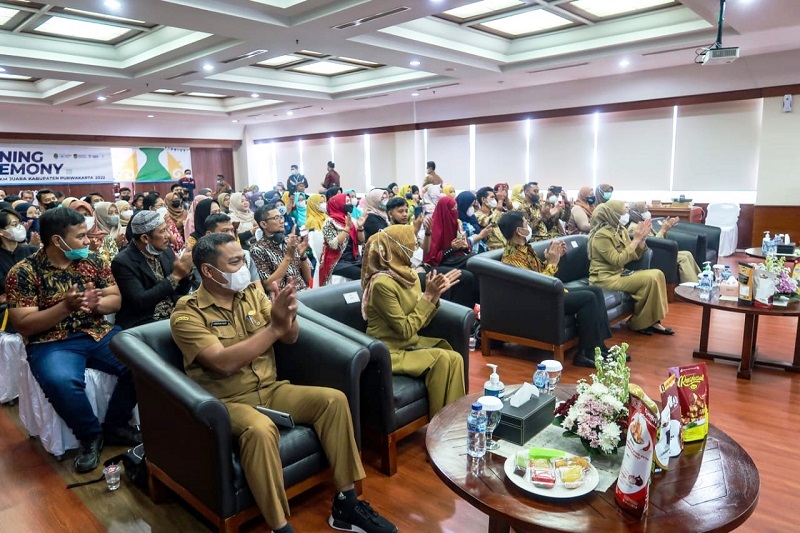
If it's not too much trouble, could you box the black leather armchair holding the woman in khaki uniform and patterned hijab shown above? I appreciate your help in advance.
[297,281,475,476]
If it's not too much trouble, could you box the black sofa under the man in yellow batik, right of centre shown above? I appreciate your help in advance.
[467,235,653,361]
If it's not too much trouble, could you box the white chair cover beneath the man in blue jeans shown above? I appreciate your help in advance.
[19,354,139,457]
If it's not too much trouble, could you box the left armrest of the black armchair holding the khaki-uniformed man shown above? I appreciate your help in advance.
[111,326,236,516]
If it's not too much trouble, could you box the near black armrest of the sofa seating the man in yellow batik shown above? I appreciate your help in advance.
[462,254,568,344]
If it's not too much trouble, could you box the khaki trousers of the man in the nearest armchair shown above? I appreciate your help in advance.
[223,381,365,528]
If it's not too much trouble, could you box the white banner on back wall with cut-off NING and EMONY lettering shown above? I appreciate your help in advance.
[0,144,114,185]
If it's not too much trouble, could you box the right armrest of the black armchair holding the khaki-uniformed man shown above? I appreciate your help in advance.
[275,316,369,447]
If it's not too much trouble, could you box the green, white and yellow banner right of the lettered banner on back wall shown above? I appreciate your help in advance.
[111,147,192,182]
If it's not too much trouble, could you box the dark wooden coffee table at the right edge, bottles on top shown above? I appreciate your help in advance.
[675,286,800,379]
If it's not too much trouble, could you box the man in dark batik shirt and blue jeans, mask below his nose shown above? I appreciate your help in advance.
[6,209,141,472]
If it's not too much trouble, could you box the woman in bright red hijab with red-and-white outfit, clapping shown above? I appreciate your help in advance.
[319,194,364,285]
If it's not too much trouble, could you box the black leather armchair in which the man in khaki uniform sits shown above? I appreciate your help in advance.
[111,317,369,532]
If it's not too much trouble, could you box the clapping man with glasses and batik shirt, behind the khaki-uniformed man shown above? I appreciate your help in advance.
[250,204,311,291]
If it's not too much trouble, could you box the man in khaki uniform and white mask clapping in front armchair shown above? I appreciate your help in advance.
[170,234,397,533]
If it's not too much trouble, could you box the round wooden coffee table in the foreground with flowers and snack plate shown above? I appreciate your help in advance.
[425,386,760,533]
